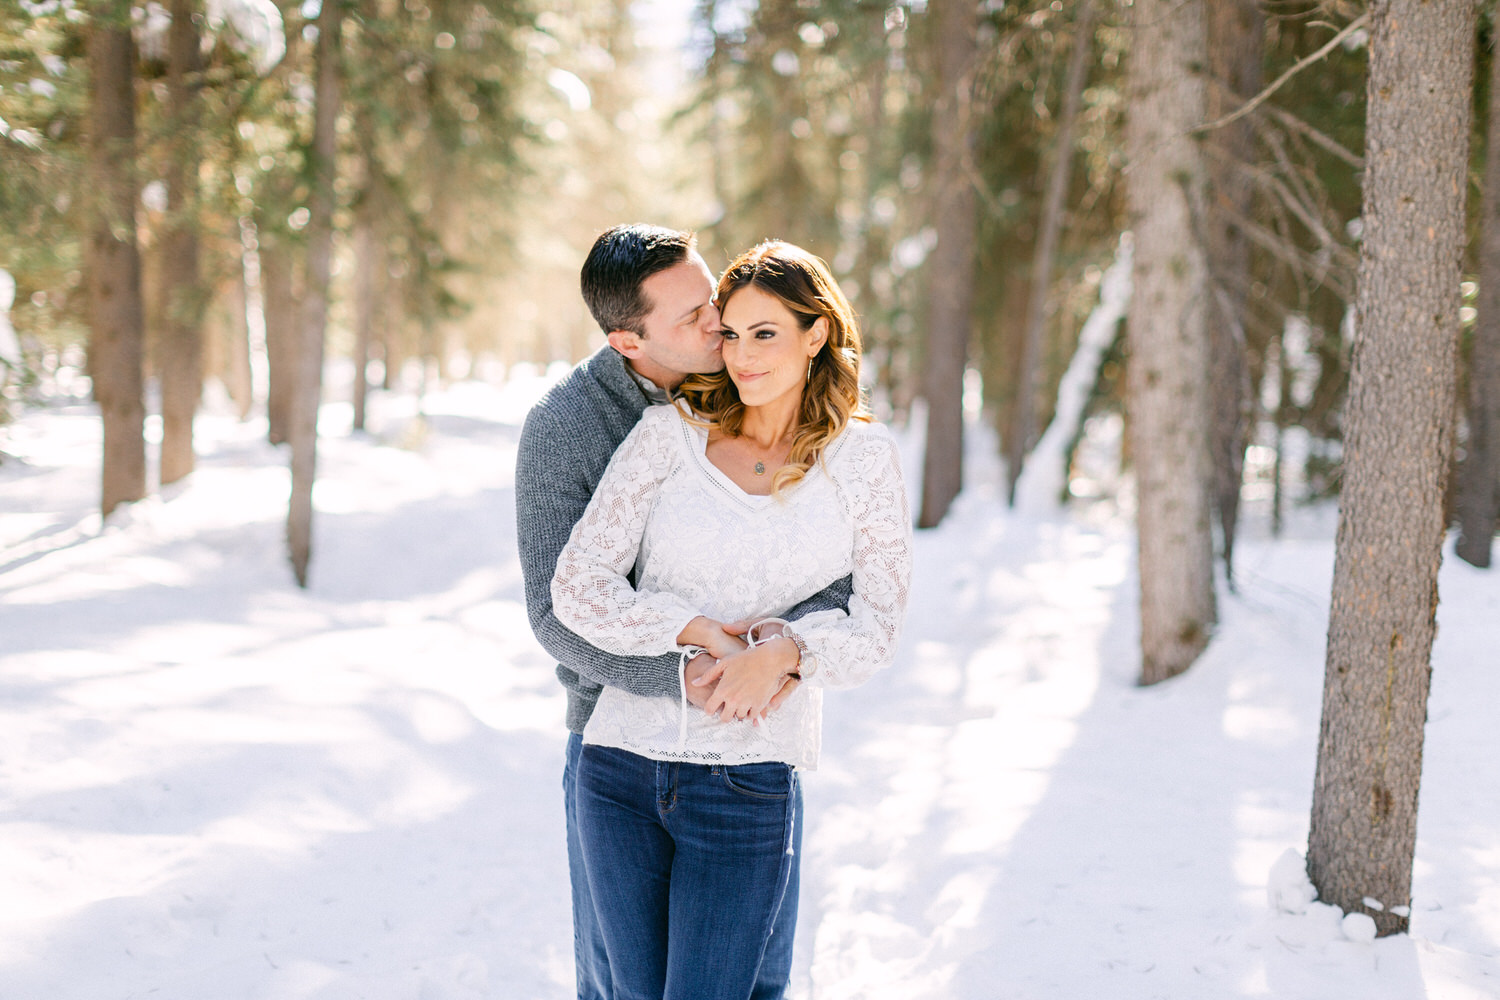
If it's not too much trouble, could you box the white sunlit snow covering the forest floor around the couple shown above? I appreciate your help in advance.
[0,377,1500,1000]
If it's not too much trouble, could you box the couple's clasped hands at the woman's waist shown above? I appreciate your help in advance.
[677,615,798,723]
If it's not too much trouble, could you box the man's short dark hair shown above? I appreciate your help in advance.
[579,223,698,336]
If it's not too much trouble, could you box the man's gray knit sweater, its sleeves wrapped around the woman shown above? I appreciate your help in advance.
[516,345,851,733]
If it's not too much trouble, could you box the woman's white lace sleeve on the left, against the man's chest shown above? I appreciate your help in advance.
[552,406,699,655]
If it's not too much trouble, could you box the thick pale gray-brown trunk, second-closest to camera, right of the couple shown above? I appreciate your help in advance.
[1125,0,1215,684]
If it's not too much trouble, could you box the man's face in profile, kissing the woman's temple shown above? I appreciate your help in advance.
[623,253,725,384]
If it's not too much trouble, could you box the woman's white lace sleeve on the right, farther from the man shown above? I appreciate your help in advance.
[794,427,912,688]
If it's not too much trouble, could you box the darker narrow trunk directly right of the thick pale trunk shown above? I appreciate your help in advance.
[1203,0,1265,589]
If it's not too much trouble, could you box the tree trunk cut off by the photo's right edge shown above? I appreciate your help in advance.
[1454,27,1500,567]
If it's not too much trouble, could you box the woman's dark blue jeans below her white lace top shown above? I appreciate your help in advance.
[575,747,801,1000]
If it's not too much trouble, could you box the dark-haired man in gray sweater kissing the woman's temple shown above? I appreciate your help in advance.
[516,225,849,1000]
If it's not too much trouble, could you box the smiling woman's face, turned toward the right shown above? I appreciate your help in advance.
[719,285,828,406]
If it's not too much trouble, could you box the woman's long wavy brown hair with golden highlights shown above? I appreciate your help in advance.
[680,240,870,495]
